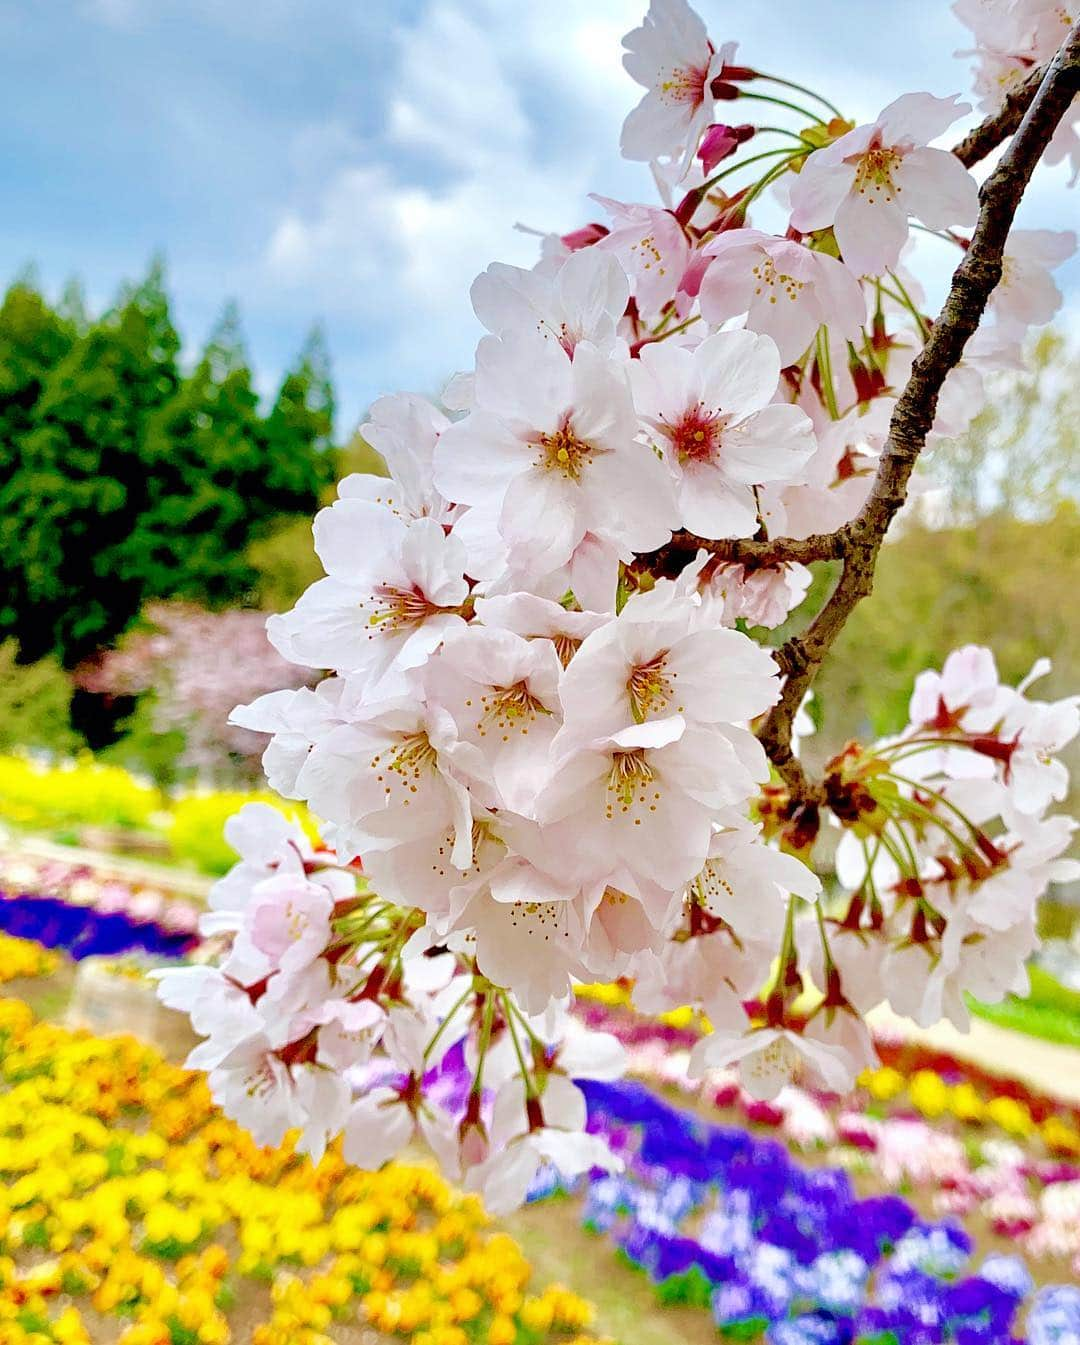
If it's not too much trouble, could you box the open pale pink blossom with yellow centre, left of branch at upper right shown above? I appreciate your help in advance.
[791,93,979,276]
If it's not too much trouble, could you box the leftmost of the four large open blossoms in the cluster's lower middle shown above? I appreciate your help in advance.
[297,699,481,869]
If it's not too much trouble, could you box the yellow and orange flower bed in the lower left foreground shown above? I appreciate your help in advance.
[0,999,607,1345]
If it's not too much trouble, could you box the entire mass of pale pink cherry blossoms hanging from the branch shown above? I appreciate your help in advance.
[161,0,1080,1209]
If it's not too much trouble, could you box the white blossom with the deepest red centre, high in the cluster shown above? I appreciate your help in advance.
[632,331,814,538]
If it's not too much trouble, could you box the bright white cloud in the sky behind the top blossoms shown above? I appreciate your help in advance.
[261,0,1080,425]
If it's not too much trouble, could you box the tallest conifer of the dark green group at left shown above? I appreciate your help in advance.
[0,262,179,667]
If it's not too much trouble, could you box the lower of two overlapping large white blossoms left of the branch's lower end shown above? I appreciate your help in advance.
[538,714,768,890]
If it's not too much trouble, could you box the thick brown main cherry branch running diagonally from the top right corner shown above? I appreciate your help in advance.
[759,23,1080,800]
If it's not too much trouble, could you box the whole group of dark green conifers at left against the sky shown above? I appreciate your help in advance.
[0,271,334,667]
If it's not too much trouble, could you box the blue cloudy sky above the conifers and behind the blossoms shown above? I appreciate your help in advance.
[0,0,1080,430]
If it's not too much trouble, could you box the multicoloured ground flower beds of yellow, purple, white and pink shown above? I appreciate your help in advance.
[0,823,1080,1345]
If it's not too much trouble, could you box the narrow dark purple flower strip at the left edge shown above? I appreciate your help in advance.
[0,893,196,960]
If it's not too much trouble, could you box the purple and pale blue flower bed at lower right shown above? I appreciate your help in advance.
[530,1080,1080,1345]
